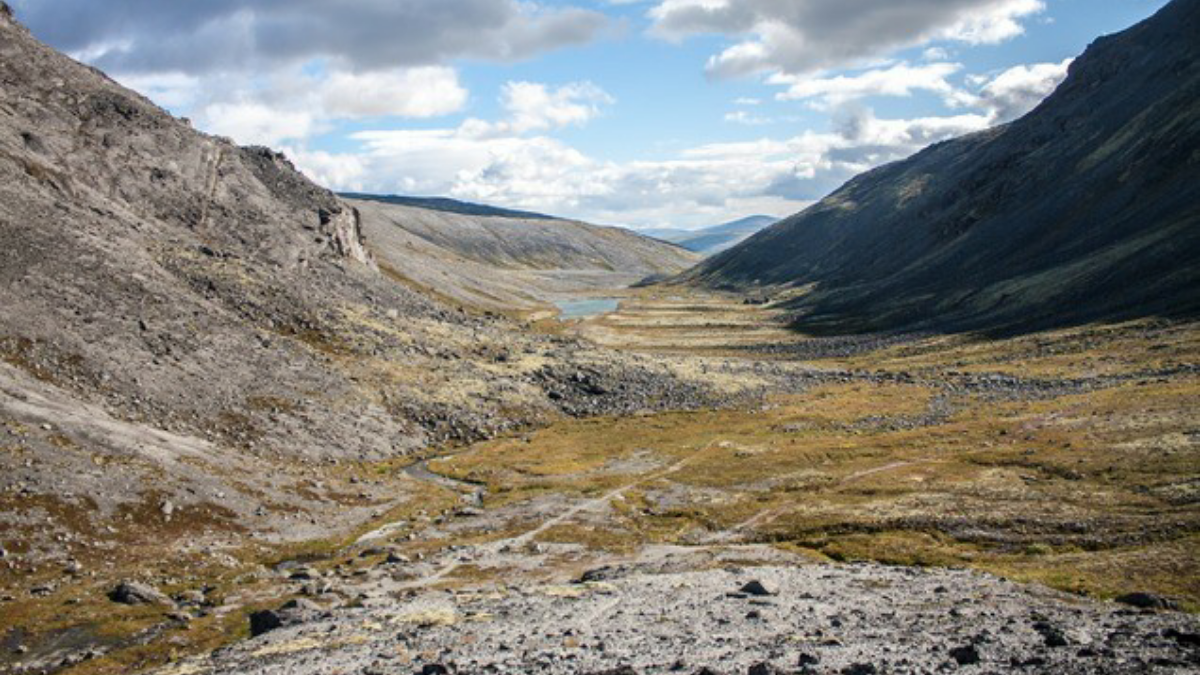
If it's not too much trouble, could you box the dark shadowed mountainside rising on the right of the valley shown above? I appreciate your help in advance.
[683,0,1200,333]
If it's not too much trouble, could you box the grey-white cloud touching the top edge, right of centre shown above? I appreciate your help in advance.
[649,0,1045,77]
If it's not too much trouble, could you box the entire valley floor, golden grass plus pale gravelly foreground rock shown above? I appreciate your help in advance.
[0,288,1200,675]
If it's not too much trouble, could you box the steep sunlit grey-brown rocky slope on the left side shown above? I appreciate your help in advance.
[0,1,703,566]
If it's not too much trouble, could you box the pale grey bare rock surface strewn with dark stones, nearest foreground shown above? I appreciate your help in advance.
[159,565,1200,675]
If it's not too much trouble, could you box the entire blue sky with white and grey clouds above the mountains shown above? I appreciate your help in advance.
[10,0,1166,229]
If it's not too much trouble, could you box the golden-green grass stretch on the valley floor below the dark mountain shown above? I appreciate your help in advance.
[415,312,1200,610]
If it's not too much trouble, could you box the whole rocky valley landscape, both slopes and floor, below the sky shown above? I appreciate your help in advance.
[0,0,1200,675]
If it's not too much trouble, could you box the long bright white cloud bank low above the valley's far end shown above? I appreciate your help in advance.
[280,78,989,227]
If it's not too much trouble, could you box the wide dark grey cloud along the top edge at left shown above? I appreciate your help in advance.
[13,0,607,73]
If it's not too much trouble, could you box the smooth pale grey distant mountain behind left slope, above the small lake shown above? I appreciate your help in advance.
[349,196,700,311]
